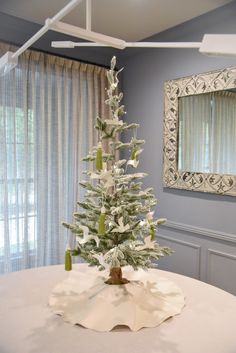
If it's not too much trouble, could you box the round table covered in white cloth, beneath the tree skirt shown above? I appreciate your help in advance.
[0,264,236,353]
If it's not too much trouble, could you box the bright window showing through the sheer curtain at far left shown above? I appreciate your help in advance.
[0,106,36,256]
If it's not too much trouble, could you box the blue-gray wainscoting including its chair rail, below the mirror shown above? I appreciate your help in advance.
[157,221,236,295]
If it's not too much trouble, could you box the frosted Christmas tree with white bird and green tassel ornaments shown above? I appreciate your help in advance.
[63,57,172,284]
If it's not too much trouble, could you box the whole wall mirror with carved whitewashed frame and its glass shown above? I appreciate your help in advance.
[163,68,236,196]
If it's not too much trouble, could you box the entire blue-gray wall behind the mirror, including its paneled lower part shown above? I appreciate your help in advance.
[120,1,236,294]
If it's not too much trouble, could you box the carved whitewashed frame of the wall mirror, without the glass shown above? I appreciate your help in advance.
[163,67,236,196]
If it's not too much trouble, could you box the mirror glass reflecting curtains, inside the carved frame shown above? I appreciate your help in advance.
[178,91,236,175]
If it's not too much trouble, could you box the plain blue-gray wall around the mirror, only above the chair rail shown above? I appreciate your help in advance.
[121,1,236,236]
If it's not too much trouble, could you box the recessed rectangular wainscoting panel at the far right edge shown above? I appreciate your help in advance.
[207,249,236,294]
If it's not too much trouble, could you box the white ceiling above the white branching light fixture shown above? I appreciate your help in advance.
[0,0,232,41]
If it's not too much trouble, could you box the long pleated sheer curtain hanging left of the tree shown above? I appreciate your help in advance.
[0,44,109,272]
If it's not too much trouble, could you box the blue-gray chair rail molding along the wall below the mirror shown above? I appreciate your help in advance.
[160,221,236,243]
